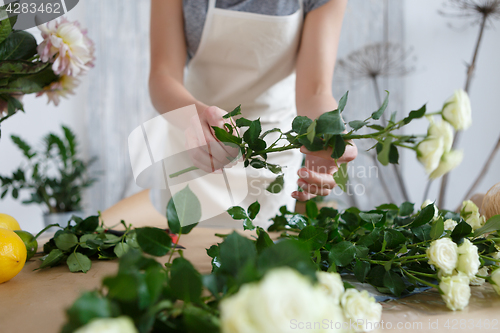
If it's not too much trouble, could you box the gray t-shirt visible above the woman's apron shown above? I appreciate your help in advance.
[182,0,329,59]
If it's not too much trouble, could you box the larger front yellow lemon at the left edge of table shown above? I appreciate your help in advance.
[0,228,27,283]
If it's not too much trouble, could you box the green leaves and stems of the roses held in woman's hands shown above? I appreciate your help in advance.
[171,92,426,193]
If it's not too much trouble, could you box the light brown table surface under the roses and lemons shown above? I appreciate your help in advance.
[0,228,500,333]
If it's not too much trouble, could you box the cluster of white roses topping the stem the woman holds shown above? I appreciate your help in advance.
[417,90,472,179]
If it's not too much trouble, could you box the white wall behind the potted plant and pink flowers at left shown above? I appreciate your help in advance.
[0,1,88,233]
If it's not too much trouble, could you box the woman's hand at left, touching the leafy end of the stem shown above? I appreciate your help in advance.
[185,106,239,173]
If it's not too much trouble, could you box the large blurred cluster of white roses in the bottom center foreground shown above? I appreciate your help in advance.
[220,268,382,333]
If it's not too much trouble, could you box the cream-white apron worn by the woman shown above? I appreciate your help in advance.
[151,0,303,228]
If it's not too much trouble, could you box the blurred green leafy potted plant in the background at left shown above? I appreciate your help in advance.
[0,126,95,230]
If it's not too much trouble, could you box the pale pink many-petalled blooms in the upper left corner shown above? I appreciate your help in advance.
[37,18,95,105]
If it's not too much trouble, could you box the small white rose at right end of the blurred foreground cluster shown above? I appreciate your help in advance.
[340,288,382,332]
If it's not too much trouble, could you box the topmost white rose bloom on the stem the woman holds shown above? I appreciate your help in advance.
[443,89,472,130]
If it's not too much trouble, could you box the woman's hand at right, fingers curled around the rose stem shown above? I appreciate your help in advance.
[292,141,358,201]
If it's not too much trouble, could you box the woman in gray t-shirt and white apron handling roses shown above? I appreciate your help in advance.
[104,0,357,227]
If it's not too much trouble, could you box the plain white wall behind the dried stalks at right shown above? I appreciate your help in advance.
[404,0,500,209]
